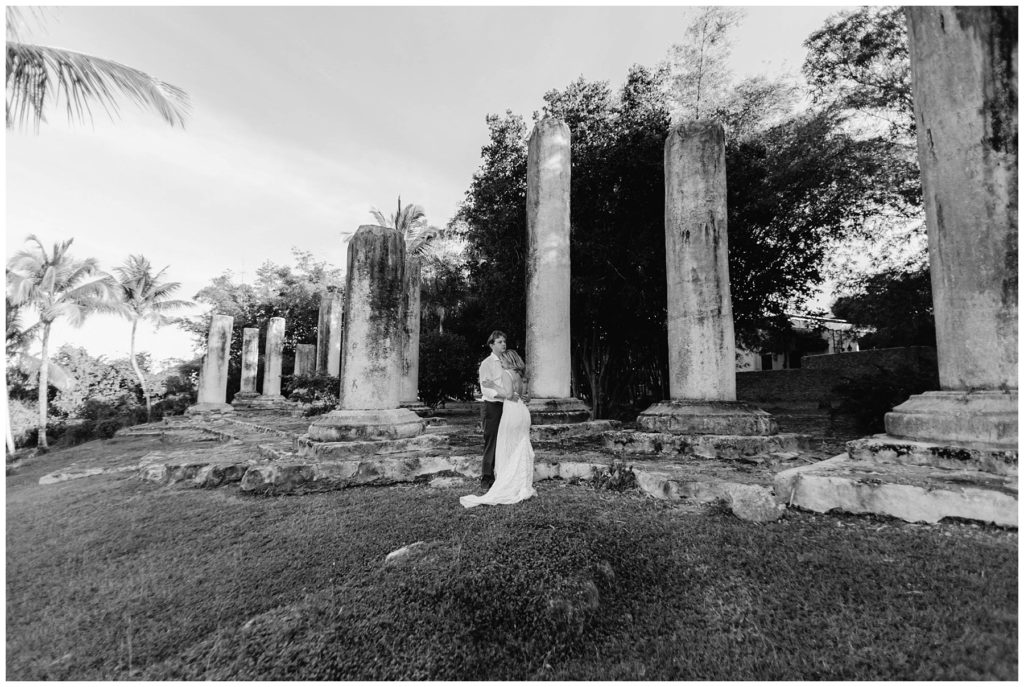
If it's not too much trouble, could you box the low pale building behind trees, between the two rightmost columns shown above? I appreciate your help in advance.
[736,313,873,372]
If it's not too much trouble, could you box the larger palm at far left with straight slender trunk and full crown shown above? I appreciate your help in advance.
[7,234,112,449]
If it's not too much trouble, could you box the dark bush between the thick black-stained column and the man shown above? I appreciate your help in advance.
[420,330,480,407]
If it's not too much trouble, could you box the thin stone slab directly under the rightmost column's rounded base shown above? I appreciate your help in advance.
[846,434,1017,477]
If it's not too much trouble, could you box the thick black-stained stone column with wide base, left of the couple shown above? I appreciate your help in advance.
[308,225,423,441]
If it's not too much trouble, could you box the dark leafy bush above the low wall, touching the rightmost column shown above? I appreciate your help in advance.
[831,265,935,348]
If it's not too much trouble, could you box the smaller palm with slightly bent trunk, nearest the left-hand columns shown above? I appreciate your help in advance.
[114,255,194,422]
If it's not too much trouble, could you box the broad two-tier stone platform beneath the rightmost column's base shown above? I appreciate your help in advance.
[774,434,1018,527]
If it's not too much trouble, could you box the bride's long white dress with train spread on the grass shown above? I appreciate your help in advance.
[459,371,537,508]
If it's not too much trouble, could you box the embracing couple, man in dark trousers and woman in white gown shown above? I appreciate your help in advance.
[459,331,537,508]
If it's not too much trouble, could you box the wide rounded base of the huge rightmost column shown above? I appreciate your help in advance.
[886,389,1017,449]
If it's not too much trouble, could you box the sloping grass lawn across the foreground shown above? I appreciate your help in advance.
[6,441,1018,680]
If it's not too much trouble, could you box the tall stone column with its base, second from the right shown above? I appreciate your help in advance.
[637,122,778,435]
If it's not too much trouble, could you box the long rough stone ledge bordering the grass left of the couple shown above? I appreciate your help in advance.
[240,456,480,493]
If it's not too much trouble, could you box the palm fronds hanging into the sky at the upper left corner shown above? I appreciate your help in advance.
[7,6,189,129]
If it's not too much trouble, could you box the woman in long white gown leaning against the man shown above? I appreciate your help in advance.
[459,350,537,508]
